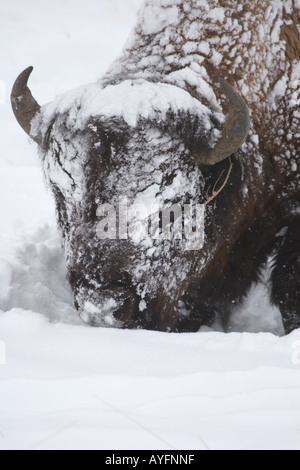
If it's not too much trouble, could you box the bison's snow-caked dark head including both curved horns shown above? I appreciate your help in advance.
[11,67,249,330]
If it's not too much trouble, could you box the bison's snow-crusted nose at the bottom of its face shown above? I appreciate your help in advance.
[76,286,140,328]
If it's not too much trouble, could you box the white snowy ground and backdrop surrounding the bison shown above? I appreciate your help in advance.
[0,0,300,450]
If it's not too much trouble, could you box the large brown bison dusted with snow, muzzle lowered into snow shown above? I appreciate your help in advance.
[12,0,300,333]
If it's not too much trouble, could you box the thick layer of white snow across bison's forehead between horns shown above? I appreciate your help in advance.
[42,80,211,130]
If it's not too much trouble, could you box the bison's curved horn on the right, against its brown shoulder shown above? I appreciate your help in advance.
[193,78,250,165]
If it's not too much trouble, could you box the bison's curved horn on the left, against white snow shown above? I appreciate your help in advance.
[11,67,41,145]
